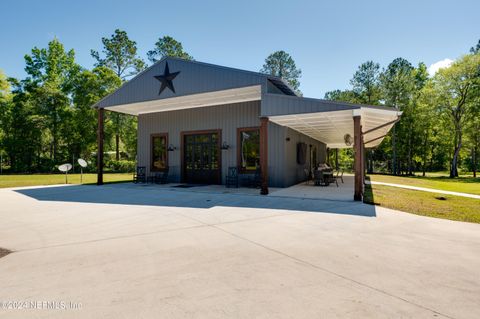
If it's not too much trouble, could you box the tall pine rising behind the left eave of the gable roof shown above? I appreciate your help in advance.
[91,29,145,161]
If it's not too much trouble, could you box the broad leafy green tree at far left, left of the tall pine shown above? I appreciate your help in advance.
[22,38,80,164]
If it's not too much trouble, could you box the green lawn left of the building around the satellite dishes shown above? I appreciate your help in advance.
[0,173,132,188]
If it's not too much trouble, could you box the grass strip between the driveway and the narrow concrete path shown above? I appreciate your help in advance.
[364,185,480,223]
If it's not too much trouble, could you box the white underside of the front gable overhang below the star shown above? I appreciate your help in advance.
[99,85,262,115]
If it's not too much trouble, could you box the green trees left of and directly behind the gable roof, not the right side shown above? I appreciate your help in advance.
[0,29,300,173]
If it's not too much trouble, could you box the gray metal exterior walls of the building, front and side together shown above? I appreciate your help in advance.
[137,101,326,187]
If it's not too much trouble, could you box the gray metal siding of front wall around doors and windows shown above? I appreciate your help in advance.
[137,101,285,186]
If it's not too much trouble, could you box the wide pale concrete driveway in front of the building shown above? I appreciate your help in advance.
[0,184,480,318]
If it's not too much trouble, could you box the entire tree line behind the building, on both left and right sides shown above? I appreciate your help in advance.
[0,29,480,177]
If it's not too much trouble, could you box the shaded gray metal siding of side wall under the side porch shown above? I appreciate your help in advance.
[283,128,327,187]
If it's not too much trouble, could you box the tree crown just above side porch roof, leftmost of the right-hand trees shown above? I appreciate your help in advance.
[350,61,380,104]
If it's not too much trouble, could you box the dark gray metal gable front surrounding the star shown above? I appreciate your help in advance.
[93,57,297,108]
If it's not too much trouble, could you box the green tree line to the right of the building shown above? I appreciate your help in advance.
[325,41,480,177]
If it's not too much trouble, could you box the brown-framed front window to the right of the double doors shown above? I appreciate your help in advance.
[237,127,260,172]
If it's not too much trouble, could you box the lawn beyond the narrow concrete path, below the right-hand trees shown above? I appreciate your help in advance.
[369,173,480,195]
